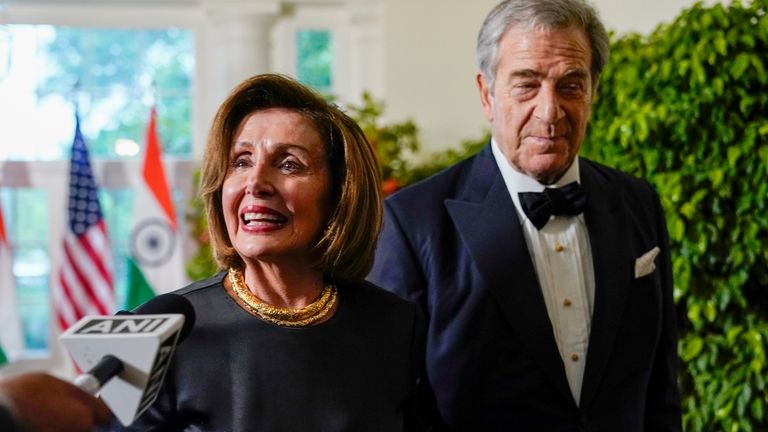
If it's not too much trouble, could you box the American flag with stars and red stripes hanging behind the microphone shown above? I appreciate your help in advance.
[53,116,115,330]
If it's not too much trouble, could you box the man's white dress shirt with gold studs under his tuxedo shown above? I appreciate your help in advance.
[491,140,595,405]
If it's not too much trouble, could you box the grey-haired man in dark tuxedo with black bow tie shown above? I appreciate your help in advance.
[369,0,681,432]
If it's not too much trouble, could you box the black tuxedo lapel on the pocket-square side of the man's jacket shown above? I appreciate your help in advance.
[580,160,632,408]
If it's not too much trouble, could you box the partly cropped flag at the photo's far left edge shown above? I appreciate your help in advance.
[0,202,24,366]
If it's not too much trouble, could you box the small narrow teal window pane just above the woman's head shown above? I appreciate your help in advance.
[296,30,333,93]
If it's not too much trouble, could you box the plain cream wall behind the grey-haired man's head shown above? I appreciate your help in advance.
[382,0,694,153]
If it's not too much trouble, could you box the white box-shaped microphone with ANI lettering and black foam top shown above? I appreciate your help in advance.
[59,294,195,426]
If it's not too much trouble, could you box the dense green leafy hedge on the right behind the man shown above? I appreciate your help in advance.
[583,0,768,431]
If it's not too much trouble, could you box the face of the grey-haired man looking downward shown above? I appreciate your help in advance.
[477,27,592,184]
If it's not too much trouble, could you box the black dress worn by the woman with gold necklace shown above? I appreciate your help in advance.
[110,272,436,432]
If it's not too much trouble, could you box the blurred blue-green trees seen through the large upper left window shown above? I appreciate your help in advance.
[38,27,194,157]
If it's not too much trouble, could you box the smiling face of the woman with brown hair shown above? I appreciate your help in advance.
[221,108,331,262]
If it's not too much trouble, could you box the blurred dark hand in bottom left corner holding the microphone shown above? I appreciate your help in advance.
[0,373,112,432]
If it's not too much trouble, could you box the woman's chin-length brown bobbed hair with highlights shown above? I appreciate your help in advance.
[200,74,382,281]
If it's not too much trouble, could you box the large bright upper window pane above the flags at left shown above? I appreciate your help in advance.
[0,25,194,160]
